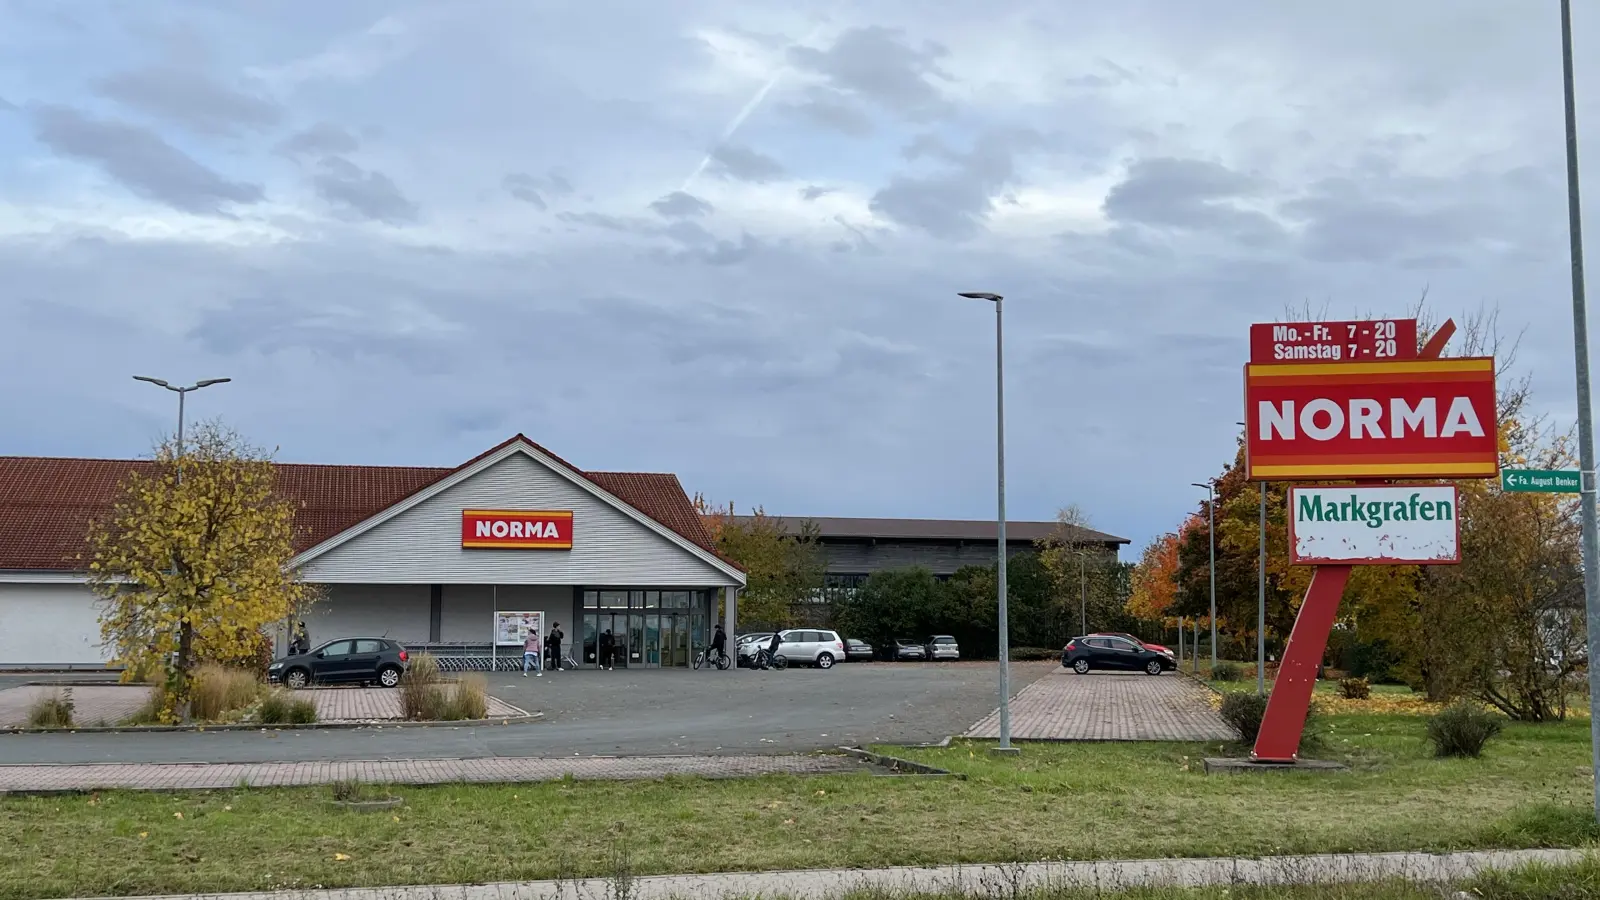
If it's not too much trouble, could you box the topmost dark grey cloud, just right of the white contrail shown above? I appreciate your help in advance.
[789,26,950,117]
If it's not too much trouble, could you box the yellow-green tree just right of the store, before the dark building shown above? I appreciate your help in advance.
[694,495,827,629]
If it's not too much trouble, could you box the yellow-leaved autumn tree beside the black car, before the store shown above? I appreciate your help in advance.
[88,423,314,722]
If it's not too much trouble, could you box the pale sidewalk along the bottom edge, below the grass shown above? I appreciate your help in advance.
[56,850,1586,900]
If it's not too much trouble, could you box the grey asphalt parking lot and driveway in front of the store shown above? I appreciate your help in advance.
[0,663,1058,764]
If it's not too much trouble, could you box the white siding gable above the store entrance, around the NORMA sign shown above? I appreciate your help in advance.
[301,447,739,588]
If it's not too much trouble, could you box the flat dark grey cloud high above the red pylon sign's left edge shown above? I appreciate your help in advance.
[1104,157,1282,235]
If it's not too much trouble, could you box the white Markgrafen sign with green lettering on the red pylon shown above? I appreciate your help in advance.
[1288,485,1461,565]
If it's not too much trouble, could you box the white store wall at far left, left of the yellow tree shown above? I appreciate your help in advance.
[0,583,110,668]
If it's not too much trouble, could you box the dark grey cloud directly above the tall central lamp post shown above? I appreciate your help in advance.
[869,131,1040,240]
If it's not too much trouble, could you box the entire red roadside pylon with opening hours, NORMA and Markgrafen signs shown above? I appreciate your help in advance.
[1245,319,1499,762]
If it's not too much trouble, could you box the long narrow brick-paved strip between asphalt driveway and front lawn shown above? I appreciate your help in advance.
[0,754,867,784]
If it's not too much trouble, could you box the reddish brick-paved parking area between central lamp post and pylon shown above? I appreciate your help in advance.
[965,669,1237,741]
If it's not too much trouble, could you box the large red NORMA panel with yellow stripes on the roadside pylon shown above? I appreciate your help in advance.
[1245,357,1499,480]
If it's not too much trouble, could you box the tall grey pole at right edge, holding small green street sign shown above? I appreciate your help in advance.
[1562,0,1600,818]
